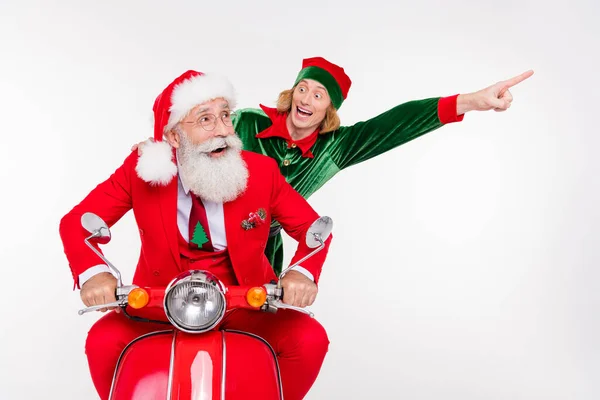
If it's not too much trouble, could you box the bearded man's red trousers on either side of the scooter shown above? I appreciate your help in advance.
[85,309,329,400]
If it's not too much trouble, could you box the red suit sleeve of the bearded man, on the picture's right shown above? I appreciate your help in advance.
[269,160,333,283]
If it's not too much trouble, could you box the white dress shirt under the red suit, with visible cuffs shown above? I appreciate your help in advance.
[79,174,314,287]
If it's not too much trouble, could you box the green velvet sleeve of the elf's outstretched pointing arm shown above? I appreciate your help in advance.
[329,97,443,170]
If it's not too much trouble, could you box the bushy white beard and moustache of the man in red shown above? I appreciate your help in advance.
[177,132,248,203]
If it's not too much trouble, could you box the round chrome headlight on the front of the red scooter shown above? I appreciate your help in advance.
[165,271,226,333]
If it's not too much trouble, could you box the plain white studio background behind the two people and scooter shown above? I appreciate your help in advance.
[0,0,600,400]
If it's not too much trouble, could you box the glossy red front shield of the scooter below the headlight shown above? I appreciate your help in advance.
[110,331,282,400]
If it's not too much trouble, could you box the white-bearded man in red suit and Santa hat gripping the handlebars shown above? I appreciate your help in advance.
[60,71,331,400]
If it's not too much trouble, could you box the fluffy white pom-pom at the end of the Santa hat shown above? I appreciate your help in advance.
[135,141,177,185]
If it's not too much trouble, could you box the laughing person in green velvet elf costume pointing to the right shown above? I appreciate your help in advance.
[134,57,533,273]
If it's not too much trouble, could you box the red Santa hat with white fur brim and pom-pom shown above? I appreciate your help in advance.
[135,70,235,185]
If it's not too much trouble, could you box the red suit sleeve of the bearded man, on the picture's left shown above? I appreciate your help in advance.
[59,153,137,287]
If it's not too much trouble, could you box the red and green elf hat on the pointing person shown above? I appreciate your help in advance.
[294,57,352,110]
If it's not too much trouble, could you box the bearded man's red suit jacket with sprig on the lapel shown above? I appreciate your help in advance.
[59,151,332,287]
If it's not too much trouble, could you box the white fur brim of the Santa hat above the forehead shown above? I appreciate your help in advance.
[164,74,236,132]
